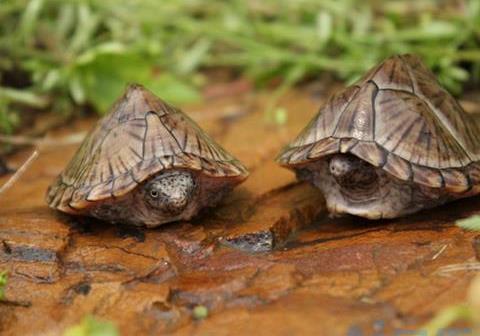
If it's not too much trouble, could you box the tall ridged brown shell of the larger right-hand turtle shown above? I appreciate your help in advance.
[277,55,480,193]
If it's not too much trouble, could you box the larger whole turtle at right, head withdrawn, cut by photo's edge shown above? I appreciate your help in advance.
[277,54,480,219]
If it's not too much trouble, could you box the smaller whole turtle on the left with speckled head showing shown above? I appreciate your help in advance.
[46,84,249,227]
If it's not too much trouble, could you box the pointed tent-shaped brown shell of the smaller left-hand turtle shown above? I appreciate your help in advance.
[47,84,248,213]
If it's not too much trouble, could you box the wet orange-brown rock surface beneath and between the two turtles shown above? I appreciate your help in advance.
[0,87,480,335]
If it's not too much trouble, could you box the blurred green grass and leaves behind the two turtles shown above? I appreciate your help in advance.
[0,0,480,132]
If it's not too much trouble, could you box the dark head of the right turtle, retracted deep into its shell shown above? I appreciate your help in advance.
[328,154,377,191]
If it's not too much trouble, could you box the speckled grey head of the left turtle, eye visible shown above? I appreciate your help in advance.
[145,171,196,216]
